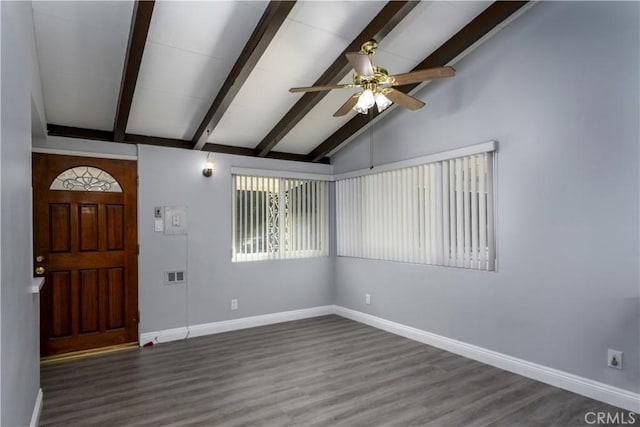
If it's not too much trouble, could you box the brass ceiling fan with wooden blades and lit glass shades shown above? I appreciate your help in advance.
[289,40,456,117]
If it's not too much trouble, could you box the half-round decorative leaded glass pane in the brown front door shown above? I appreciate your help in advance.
[49,166,122,193]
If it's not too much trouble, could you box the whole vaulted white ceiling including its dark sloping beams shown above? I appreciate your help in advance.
[33,1,527,162]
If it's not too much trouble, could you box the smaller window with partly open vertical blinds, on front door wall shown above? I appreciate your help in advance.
[232,174,329,262]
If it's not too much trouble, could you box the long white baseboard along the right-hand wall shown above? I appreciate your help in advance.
[334,306,640,412]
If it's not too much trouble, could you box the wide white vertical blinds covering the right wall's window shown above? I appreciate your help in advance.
[336,152,495,270]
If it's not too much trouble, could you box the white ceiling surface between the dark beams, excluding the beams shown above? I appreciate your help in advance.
[33,1,524,160]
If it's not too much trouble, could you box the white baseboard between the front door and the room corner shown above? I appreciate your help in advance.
[140,305,333,346]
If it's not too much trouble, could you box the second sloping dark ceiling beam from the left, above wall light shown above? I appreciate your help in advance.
[192,0,296,150]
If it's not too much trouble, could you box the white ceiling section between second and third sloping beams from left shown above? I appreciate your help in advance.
[208,2,385,148]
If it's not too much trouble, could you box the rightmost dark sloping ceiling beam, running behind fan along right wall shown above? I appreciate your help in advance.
[308,1,528,162]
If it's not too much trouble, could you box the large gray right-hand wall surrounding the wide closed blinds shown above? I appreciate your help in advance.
[333,2,640,392]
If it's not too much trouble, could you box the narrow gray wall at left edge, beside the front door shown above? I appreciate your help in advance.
[0,1,40,426]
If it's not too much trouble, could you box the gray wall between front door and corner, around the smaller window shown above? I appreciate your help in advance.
[138,146,333,332]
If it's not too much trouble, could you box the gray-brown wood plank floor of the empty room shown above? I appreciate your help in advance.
[40,316,640,427]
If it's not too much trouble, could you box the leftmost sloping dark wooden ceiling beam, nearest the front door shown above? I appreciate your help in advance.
[113,0,155,142]
